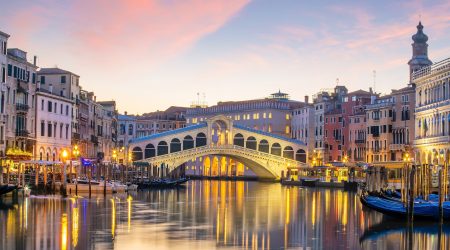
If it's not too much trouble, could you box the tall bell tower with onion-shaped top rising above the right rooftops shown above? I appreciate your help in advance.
[408,22,432,82]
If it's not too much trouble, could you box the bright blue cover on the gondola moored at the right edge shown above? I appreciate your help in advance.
[360,194,450,220]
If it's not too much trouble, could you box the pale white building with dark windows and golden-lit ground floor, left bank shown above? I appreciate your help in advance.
[34,89,73,161]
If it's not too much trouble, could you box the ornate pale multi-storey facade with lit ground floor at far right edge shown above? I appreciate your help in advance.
[412,58,450,165]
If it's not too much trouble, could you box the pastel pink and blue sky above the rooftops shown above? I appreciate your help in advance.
[0,0,450,114]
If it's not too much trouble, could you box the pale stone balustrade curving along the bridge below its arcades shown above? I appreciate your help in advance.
[138,145,306,166]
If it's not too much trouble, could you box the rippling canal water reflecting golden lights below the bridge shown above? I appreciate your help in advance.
[0,180,450,250]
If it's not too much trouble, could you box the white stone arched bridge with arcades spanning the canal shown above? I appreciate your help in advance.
[129,116,308,179]
